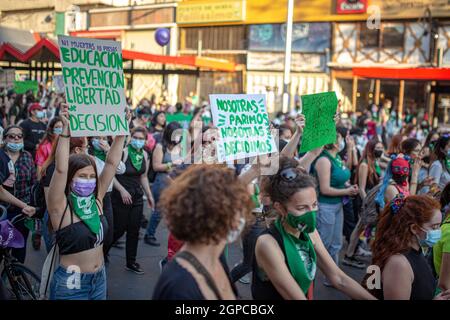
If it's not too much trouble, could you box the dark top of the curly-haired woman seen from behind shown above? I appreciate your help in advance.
[152,254,237,300]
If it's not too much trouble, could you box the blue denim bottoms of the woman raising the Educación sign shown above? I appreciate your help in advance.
[50,266,106,300]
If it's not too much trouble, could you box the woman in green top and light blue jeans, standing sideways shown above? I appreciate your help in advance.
[312,127,359,285]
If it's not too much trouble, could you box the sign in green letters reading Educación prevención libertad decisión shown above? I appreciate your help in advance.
[58,36,129,137]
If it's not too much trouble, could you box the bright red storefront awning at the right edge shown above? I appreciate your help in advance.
[352,68,450,81]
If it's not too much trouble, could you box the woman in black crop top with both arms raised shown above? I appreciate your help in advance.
[47,105,125,300]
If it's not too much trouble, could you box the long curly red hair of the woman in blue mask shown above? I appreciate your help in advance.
[372,195,441,270]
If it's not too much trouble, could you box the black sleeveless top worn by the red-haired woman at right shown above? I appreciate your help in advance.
[377,249,437,300]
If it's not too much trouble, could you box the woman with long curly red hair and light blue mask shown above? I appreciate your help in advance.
[366,194,450,300]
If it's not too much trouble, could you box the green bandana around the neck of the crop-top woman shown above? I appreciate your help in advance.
[70,192,100,234]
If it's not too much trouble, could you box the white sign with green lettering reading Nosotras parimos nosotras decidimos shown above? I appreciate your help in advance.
[209,94,277,162]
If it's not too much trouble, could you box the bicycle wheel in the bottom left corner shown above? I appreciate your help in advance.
[2,263,41,300]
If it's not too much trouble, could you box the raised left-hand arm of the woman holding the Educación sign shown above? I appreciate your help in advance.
[47,104,70,214]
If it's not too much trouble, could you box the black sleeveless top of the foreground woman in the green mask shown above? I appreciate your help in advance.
[252,226,288,300]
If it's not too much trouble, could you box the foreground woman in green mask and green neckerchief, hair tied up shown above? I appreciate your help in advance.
[252,157,374,300]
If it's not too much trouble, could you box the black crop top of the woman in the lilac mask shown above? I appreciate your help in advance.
[55,202,109,255]
